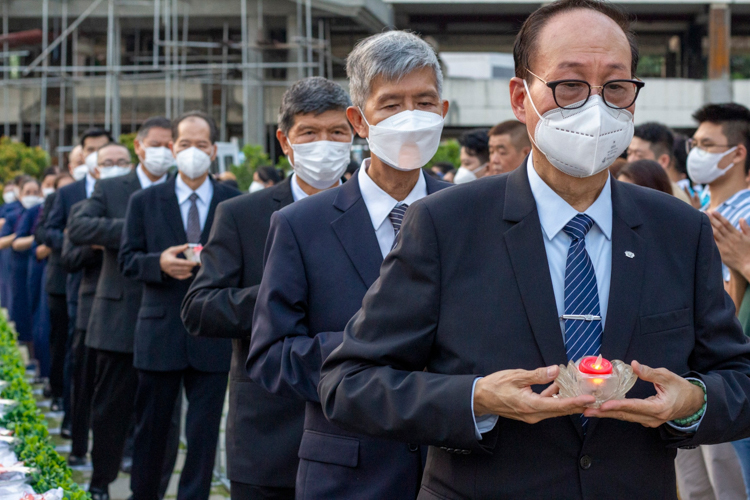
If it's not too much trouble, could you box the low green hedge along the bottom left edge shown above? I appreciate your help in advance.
[0,317,90,500]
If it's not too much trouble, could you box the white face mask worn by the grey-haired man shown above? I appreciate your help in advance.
[359,109,445,171]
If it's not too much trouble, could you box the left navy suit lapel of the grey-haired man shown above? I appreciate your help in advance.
[331,170,383,288]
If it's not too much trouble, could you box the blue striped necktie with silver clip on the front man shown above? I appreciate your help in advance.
[563,214,602,432]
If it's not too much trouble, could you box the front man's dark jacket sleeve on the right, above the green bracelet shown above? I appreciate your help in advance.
[662,215,750,447]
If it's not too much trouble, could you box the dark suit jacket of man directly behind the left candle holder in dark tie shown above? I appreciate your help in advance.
[68,169,142,353]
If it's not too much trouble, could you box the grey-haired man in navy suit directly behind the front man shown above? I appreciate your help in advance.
[247,32,449,500]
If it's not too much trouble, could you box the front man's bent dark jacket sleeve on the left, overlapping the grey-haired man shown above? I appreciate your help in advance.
[319,202,486,451]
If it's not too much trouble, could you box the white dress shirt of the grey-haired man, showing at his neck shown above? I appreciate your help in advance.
[357,158,427,258]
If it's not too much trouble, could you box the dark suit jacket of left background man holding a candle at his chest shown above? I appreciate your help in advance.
[119,178,240,372]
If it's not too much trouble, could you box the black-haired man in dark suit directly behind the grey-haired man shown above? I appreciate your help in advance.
[182,77,350,500]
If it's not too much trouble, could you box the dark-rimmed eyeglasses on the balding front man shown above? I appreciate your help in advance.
[526,69,645,109]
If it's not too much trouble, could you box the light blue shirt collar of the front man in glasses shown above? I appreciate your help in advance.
[526,155,612,240]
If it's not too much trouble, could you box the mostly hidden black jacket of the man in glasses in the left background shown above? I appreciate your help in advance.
[60,200,102,331]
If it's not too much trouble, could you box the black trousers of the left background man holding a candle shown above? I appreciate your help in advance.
[130,368,228,500]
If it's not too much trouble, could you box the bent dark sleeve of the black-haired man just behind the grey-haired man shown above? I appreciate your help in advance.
[182,203,260,338]
